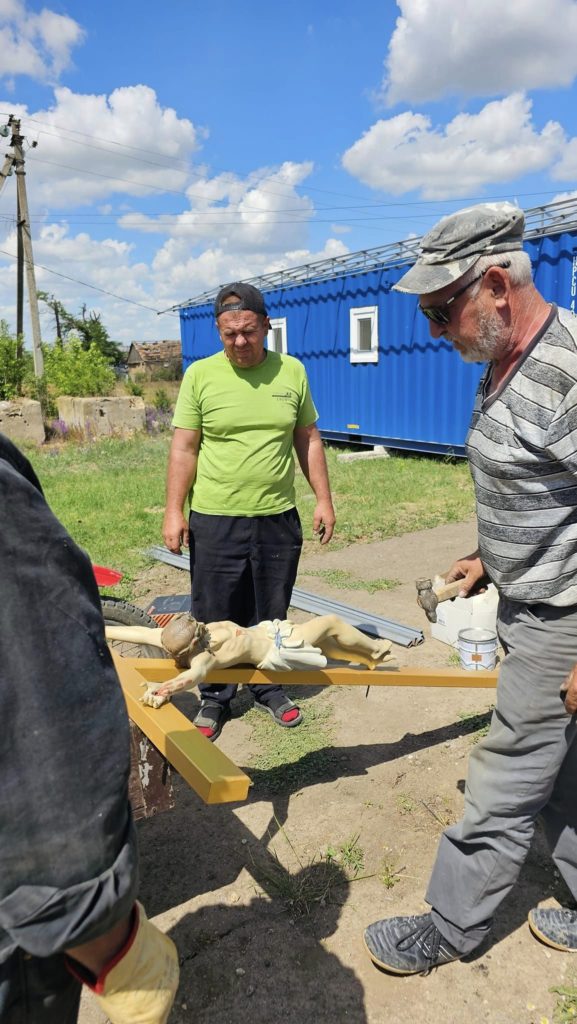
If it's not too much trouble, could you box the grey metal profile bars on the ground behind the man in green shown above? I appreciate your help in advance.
[148,546,424,647]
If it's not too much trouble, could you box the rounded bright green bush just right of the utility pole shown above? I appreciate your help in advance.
[44,335,116,397]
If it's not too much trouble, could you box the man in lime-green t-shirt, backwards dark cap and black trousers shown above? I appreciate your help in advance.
[163,282,335,739]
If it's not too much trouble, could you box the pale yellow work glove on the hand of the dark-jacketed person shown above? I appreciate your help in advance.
[89,902,178,1024]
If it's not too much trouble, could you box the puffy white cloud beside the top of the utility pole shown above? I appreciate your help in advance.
[0,85,200,209]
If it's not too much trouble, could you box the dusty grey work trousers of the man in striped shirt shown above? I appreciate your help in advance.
[426,598,577,955]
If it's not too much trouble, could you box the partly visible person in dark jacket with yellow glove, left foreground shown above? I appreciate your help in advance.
[0,434,178,1024]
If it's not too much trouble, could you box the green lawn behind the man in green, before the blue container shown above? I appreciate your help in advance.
[21,432,473,598]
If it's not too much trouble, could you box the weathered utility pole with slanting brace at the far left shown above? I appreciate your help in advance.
[0,114,44,377]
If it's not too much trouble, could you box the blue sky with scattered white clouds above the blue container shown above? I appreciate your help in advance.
[0,0,577,344]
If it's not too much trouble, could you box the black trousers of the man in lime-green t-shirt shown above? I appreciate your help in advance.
[190,508,302,705]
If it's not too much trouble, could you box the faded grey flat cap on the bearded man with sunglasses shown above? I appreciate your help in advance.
[394,203,525,295]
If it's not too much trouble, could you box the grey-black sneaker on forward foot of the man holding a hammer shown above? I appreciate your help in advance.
[365,913,464,974]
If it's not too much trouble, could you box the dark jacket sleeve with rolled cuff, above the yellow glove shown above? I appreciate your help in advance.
[0,435,137,959]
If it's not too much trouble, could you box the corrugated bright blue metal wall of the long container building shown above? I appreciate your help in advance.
[180,233,577,455]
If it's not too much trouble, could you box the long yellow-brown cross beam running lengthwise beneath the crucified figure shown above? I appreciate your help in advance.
[123,657,499,692]
